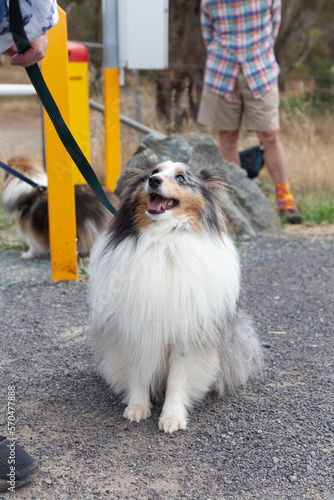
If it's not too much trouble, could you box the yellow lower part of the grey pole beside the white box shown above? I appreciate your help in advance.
[104,68,121,191]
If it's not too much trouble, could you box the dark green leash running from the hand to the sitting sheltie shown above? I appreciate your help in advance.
[9,0,116,214]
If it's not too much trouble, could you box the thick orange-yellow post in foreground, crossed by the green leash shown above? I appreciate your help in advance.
[42,7,77,281]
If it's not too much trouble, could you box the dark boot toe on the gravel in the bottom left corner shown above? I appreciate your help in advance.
[0,436,39,492]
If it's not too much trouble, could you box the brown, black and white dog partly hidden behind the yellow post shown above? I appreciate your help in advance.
[2,158,119,259]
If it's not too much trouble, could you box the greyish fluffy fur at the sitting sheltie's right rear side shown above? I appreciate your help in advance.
[217,311,263,395]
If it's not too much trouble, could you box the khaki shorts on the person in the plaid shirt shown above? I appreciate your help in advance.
[197,72,280,132]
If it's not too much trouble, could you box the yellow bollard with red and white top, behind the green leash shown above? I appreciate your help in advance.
[67,41,90,184]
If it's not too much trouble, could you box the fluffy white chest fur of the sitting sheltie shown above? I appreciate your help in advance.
[90,224,239,357]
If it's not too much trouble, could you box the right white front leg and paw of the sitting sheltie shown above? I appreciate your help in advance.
[159,349,219,434]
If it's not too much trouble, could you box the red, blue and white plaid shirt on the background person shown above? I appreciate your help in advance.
[201,0,281,100]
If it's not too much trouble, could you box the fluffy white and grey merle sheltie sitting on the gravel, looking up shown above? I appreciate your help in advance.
[89,159,262,433]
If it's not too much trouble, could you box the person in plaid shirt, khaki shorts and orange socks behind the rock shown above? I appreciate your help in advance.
[197,0,302,224]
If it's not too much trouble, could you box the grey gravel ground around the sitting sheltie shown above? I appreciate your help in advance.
[0,235,334,500]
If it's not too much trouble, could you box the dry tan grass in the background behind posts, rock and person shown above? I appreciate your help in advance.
[0,62,334,197]
